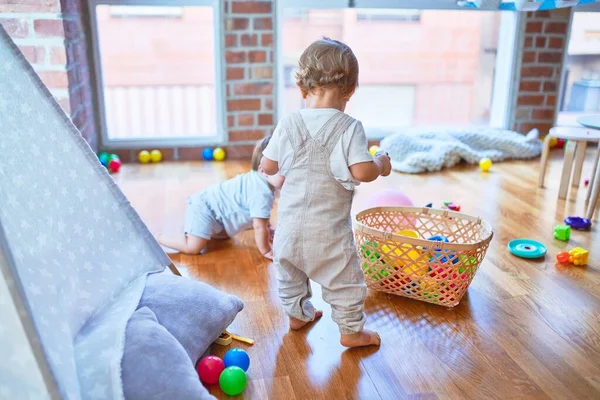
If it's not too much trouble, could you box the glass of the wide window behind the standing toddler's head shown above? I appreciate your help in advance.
[279,3,517,138]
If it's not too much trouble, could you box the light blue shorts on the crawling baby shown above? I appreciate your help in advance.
[184,193,227,240]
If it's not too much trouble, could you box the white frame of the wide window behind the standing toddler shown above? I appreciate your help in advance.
[275,0,525,134]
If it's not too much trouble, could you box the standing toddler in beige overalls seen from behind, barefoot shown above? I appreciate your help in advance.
[261,38,391,347]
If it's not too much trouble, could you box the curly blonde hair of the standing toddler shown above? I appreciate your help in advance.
[296,37,358,96]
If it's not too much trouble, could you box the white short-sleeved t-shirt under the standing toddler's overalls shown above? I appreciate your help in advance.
[263,108,373,190]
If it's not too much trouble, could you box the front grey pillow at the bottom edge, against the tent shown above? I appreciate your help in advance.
[121,307,214,400]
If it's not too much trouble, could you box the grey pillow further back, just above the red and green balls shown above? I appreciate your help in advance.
[138,273,244,363]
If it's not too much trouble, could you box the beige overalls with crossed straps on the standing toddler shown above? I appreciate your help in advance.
[273,112,367,334]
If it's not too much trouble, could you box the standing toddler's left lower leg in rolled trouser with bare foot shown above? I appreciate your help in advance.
[275,259,323,330]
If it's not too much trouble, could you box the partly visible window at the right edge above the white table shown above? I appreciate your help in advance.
[557,12,600,125]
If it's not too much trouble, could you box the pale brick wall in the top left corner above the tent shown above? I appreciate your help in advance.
[0,0,96,152]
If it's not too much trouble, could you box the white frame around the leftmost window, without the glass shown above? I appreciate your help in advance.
[88,0,227,150]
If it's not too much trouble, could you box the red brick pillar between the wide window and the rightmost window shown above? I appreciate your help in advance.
[513,9,571,135]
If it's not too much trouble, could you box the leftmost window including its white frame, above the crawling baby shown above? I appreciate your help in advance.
[91,0,222,147]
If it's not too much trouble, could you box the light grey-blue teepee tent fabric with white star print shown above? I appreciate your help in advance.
[0,27,170,399]
